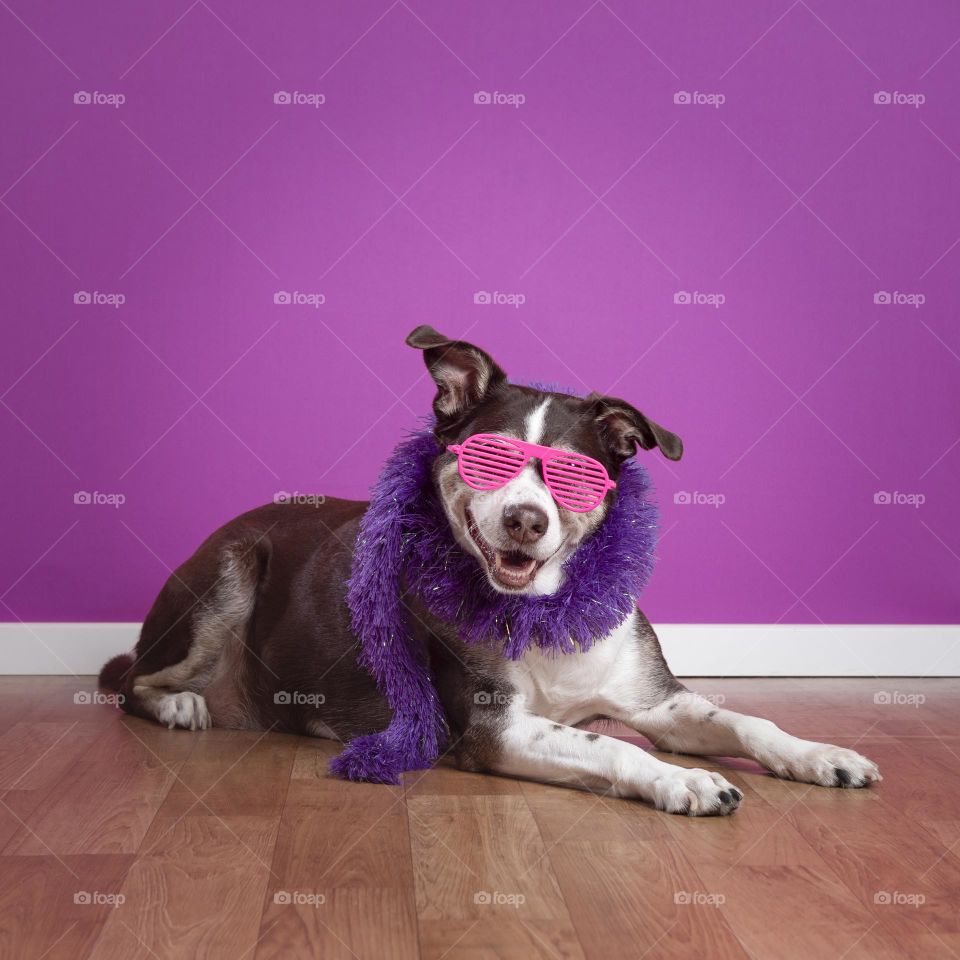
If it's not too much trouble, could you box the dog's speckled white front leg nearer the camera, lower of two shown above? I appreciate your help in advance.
[462,708,742,816]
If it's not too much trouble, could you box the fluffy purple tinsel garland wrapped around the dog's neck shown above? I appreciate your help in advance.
[331,429,657,783]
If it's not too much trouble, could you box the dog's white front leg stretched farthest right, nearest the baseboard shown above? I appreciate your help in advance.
[618,690,881,787]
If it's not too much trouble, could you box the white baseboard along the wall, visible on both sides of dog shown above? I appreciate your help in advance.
[0,623,960,677]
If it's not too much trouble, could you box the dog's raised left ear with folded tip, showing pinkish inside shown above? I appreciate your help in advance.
[407,324,507,425]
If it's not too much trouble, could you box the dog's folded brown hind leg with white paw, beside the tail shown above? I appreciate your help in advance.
[101,539,269,730]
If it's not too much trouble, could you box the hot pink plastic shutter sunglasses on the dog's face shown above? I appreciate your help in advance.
[447,433,616,513]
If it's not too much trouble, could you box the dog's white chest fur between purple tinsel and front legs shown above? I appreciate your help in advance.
[508,616,640,725]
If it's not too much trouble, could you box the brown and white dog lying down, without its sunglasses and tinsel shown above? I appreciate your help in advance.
[100,326,881,816]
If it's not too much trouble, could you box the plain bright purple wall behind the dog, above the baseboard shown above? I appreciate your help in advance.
[0,0,960,623]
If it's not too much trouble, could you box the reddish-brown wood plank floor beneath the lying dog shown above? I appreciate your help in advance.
[0,677,960,960]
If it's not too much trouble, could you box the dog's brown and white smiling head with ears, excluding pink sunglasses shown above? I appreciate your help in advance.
[407,326,683,594]
